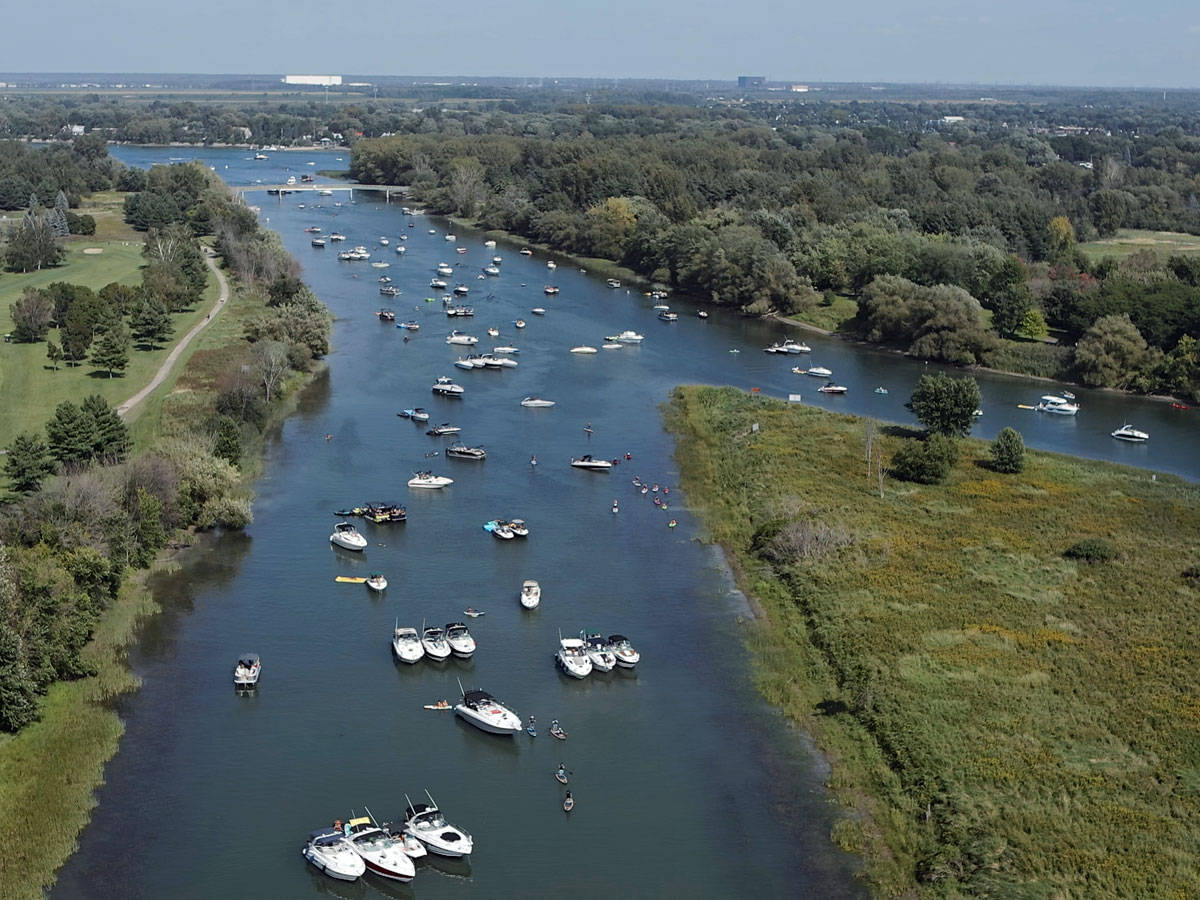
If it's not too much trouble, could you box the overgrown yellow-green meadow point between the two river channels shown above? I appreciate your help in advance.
[667,388,1200,896]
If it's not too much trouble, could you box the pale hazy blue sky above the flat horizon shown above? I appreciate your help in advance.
[9,0,1200,88]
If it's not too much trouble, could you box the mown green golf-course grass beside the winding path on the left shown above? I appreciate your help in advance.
[0,239,217,446]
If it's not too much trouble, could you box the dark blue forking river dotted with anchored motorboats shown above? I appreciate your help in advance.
[54,148,1200,898]
